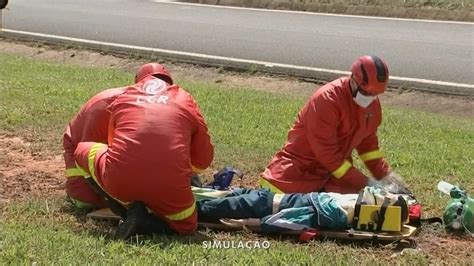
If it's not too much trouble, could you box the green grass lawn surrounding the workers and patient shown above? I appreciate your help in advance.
[0,54,474,265]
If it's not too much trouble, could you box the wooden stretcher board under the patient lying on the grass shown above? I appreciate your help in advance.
[87,208,417,241]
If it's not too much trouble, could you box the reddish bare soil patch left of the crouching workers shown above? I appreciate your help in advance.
[0,134,65,206]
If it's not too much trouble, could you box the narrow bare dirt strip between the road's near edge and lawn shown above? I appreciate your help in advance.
[0,39,474,118]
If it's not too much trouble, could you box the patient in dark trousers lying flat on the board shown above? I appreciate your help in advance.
[193,187,408,233]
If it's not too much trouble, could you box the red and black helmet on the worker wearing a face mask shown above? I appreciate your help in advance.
[351,55,388,95]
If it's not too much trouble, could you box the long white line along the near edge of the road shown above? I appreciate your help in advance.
[1,29,474,89]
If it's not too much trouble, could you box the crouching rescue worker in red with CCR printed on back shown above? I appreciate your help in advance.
[74,64,214,237]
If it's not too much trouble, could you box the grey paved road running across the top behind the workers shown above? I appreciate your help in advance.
[3,0,474,93]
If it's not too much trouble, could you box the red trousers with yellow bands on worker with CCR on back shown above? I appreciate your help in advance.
[74,142,197,234]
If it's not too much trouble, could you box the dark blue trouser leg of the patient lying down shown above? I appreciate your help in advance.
[196,190,274,222]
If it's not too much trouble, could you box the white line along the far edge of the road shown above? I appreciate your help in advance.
[149,0,474,25]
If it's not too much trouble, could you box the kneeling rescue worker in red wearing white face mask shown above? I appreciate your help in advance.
[260,56,401,193]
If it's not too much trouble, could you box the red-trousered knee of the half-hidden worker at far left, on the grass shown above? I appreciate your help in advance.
[66,177,106,209]
